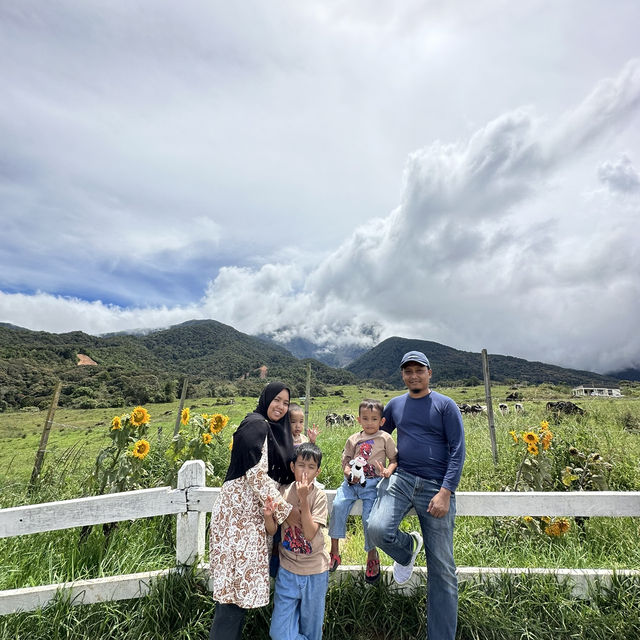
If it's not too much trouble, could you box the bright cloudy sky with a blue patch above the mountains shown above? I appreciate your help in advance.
[0,0,640,372]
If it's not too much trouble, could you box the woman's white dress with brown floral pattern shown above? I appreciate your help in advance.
[209,438,291,609]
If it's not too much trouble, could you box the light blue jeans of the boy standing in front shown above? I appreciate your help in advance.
[269,567,329,640]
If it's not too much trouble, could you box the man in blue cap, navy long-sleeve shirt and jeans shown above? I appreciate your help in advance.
[368,351,465,640]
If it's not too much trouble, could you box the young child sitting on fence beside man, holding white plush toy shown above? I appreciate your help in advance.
[329,400,398,583]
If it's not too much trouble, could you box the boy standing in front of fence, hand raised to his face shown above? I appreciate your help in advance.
[264,442,329,640]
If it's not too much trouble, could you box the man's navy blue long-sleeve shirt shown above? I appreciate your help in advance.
[381,391,465,491]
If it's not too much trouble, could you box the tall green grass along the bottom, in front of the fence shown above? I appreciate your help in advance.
[0,574,640,640]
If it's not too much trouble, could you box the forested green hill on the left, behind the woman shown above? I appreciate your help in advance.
[0,320,355,410]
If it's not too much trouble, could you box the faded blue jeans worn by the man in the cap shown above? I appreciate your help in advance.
[368,470,458,640]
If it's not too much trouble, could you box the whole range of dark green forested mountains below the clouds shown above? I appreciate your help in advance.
[0,320,617,411]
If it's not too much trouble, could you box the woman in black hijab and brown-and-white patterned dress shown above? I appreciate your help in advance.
[209,382,294,640]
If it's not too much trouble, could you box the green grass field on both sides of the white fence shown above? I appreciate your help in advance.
[0,385,640,639]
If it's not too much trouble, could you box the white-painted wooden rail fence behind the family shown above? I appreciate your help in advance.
[0,460,640,615]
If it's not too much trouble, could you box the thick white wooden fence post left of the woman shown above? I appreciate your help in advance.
[176,460,207,566]
